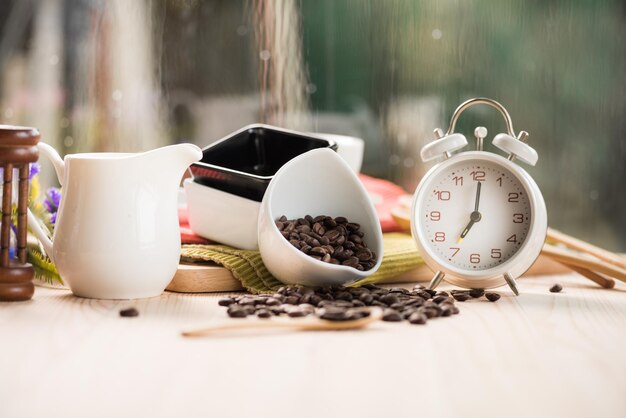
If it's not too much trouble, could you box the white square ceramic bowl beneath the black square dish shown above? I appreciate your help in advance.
[184,179,260,250]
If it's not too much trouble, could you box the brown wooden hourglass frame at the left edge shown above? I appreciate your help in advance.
[0,125,39,301]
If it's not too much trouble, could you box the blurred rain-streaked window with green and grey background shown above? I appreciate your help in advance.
[0,0,626,251]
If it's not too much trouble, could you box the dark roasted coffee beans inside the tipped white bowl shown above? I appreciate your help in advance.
[276,215,377,271]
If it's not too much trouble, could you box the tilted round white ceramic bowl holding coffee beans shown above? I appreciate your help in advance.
[258,149,383,286]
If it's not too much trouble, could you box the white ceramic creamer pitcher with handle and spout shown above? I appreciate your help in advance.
[28,143,202,299]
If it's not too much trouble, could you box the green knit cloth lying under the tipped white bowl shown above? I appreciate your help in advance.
[181,233,423,293]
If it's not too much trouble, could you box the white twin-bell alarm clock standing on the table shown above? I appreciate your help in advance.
[411,98,548,295]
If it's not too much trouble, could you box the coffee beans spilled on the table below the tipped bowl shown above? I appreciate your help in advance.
[219,285,459,325]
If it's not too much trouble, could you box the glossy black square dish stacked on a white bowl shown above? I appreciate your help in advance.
[190,124,337,202]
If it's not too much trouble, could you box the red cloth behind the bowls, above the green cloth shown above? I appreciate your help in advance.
[178,174,406,244]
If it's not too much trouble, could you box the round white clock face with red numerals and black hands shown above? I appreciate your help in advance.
[413,159,533,272]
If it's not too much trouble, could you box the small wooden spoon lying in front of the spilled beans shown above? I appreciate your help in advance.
[182,308,383,337]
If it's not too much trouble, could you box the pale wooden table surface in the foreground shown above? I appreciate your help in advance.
[0,275,626,418]
